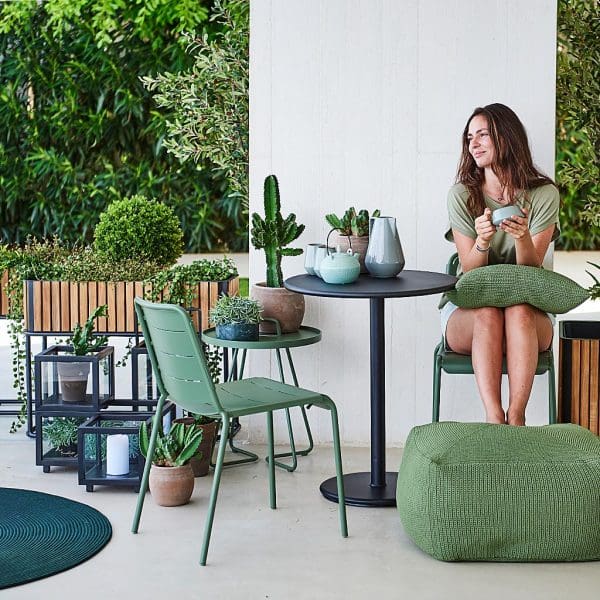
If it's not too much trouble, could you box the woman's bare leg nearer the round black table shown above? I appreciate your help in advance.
[446,307,506,423]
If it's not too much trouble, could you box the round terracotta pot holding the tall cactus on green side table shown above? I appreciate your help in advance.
[250,281,305,333]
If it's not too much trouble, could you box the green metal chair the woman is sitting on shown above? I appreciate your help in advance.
[432,254,556,423]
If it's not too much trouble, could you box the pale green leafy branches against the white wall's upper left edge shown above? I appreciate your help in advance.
[143,0,250,209]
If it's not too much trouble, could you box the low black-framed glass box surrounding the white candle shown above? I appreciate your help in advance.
[77,402,175,492]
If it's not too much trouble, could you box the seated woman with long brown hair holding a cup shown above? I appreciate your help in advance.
[442,104,559,425]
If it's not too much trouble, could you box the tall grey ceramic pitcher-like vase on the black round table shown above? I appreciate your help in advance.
[365,217,404,278]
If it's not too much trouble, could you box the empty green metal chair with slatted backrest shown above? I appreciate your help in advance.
[131,298,348,565]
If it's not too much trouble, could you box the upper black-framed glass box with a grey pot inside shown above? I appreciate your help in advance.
[35,345,115,414]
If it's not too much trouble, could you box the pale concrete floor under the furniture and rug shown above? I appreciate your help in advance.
[0,422,600,600]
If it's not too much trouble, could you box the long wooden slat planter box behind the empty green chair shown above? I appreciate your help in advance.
[23,277,239,335]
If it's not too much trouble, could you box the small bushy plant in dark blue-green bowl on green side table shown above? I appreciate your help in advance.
[210,295,262,342]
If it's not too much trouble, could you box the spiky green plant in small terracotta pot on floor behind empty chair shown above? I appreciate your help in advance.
[139,419,202,506]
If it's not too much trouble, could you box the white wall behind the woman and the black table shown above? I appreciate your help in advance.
[248,0,556,445]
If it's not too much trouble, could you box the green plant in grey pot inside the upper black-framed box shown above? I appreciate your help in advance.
[56,304,108,404]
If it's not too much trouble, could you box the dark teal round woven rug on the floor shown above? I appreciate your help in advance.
[0,488,112,589]
